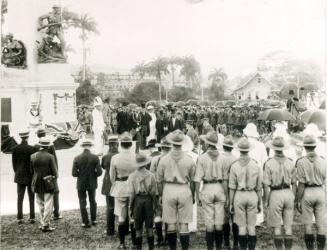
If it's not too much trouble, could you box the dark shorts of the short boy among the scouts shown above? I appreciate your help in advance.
[133,195,154,230]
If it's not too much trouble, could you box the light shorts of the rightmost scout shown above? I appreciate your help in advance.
[301,187,327,226]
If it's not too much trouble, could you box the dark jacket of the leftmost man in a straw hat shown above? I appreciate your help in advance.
[12,141,37,185]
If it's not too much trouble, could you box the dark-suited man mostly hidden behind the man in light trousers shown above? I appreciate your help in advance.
[35,128,62,220]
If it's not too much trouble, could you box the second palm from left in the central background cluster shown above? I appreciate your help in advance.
[147,56,169,103]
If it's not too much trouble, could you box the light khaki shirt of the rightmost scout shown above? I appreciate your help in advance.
[296,150,326,185]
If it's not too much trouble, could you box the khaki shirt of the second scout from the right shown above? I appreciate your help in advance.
[263,155,296,187]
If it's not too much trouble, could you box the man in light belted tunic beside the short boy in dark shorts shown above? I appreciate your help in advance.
[109,132,136,249]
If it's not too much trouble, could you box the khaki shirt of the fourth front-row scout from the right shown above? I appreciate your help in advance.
[194,150,227,182]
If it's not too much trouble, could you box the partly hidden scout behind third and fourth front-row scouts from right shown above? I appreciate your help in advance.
[221,135,238,250]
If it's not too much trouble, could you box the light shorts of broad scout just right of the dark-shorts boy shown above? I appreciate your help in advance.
[162,183,193,224]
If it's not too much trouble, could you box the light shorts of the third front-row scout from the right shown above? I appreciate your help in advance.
[234,191,258,227]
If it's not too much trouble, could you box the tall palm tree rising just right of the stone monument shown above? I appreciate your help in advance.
[71,14,100,81]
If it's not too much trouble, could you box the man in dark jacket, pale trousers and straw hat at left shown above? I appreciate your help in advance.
[31,137,58,232]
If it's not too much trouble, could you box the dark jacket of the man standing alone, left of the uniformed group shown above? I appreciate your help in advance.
[72,149,102,190]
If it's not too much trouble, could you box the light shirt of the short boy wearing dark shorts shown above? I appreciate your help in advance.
[128,169,158,195]
